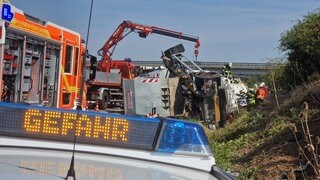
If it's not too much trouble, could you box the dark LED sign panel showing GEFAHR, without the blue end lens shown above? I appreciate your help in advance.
[0,102,160,150]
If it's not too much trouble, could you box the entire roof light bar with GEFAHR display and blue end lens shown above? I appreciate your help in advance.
[0,102,212,156]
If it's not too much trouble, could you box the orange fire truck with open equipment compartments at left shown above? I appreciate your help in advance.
[0,4,85,109]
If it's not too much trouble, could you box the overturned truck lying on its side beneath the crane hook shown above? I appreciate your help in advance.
[123,44,245,128]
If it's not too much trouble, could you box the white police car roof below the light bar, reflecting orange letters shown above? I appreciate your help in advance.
[0,141,217,180]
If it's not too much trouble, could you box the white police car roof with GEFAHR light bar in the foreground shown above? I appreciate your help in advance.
[0,102,236,180]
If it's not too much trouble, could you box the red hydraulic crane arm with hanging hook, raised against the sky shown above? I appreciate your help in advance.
[98,21,200,63]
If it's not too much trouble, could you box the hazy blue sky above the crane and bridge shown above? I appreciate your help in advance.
[11,0,320,63]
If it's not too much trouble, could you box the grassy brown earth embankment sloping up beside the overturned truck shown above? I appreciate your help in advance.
[209,82,320,179]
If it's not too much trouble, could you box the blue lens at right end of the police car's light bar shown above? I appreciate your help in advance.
[156,118,212,156]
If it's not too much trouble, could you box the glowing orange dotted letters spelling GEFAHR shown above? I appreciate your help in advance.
[24,109,129,141]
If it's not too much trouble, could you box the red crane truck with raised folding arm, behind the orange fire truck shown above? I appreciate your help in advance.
[86,21,200,109]
